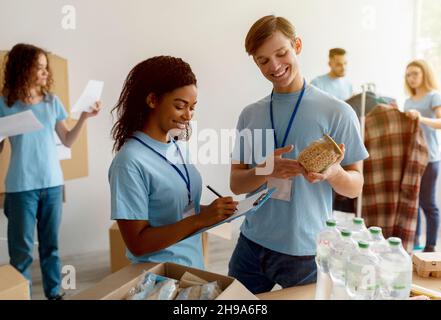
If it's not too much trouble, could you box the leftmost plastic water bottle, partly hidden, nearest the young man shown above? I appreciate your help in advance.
[315,219,340,300]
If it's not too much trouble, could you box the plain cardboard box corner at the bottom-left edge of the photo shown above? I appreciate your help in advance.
[0,265,30,300]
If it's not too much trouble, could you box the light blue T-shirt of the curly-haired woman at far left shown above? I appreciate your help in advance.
[0,95,67,192]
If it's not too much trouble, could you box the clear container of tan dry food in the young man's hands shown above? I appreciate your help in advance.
[297,134,343,173]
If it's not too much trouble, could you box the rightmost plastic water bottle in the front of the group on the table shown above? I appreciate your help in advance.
[380,237,412,300]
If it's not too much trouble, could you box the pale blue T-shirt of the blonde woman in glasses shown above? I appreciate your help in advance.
[404,91,441,162]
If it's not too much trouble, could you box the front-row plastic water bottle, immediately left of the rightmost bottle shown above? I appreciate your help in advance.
[346,240,380,300]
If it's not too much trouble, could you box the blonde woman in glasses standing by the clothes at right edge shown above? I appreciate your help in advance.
[404,60,441,252]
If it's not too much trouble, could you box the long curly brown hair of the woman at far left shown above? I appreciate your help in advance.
[1,43,53,107]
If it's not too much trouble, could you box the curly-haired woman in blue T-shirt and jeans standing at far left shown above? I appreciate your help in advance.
[0,44,101,299]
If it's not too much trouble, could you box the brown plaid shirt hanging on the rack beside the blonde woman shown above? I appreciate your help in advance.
[362,105,428,252]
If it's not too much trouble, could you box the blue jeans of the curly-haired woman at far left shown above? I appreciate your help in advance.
[5,186,63,298]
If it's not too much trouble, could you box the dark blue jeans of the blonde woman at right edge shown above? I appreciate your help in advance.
[416,161,440,247]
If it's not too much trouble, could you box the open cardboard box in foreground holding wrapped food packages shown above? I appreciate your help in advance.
[70,263,258,300]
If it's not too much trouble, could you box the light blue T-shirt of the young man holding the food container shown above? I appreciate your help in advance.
[232,86,368,256]
